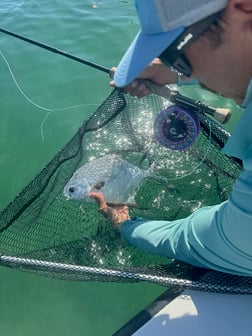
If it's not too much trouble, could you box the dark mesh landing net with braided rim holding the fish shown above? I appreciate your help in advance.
[0,89,252,293]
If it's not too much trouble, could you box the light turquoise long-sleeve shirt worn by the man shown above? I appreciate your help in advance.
[120,81,252,276]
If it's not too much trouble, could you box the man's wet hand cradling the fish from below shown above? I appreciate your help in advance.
[88,191,130,225]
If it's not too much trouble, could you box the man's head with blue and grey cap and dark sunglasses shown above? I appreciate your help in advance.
[114,0,252,102]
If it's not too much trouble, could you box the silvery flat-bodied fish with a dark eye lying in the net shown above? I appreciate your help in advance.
[63,154,151,205]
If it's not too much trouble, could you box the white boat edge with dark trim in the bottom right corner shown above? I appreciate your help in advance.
[113,288,252,336]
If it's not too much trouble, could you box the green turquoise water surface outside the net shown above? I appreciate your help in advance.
[0,0,243,336]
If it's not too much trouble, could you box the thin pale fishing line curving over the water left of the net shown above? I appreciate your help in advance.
[0,50,98,142]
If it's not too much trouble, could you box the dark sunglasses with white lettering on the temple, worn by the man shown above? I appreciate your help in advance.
[159,12,220,77]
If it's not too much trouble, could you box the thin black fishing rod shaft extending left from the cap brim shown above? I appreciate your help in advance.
[0,28,110,74]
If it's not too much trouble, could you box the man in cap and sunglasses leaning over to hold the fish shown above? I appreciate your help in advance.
[91,0,252,276]
